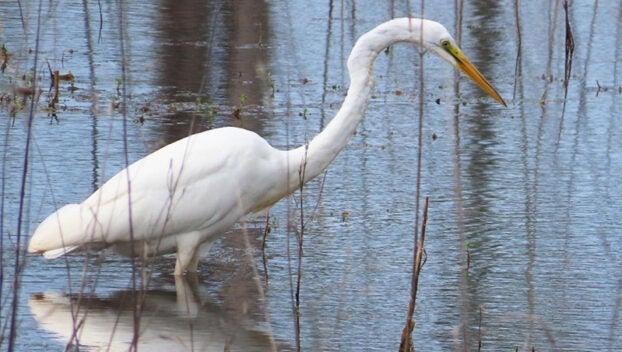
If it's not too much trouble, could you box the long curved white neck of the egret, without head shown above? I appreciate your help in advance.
[288,18,421,191]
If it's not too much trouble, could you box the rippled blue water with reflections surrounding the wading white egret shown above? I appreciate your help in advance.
[0,1,622,351]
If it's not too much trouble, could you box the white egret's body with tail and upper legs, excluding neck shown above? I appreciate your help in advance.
[30,127,308,270]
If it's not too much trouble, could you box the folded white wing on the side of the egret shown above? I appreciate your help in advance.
[77,128,268,242]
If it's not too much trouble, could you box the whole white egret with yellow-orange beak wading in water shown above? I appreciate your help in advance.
[28,18,506,275]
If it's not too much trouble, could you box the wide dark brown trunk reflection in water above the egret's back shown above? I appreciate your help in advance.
[154,0,271,143]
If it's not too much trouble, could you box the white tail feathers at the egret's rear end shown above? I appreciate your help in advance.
[28,204,92,258]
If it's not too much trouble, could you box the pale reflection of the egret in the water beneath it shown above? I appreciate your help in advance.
[29,277,282,352]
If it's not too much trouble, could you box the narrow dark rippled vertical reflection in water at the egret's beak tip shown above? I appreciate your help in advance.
[455,0,508,350]
